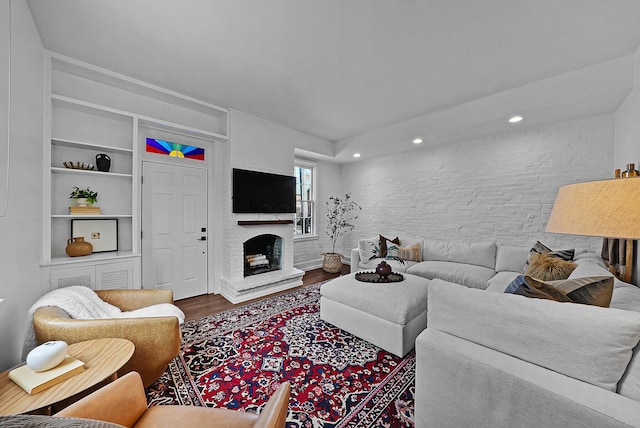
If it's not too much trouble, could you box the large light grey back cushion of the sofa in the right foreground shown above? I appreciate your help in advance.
[427,279,640,392]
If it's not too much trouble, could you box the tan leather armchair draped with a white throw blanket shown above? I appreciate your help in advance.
[33,290,181,387]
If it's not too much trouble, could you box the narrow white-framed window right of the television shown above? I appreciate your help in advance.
[293,161,316,237]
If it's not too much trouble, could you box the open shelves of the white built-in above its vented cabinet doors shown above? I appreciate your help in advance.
[44,93,138,265]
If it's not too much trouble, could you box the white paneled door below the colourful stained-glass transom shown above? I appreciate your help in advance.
[142,162,208,300]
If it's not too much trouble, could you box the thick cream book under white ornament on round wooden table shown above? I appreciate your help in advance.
[9,355,84,395]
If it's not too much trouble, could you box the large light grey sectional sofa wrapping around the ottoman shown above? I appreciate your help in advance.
[351,237,640,428]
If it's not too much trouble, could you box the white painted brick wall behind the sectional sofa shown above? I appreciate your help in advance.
[340,115,614,254]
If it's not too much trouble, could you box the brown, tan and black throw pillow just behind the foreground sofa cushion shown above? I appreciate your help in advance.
[505,275,613,308]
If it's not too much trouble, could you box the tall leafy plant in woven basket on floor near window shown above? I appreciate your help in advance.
[322,193,362,273]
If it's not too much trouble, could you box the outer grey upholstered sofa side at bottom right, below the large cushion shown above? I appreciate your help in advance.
[415,328,640,428]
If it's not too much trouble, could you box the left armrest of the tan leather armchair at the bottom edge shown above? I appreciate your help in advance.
[55,372,147,427]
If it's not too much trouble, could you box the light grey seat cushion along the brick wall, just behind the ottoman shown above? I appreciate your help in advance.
[407,261,495,290]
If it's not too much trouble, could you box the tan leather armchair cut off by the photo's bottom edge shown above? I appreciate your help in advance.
[54,373,291,428]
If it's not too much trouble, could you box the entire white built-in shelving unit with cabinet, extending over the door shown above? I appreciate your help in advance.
[42,52,228,288]
